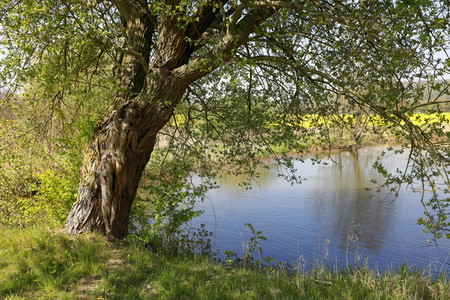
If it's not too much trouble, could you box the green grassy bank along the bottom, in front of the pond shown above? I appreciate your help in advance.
[0,229,450,299]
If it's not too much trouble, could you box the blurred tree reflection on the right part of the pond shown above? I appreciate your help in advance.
[311,152,395,253]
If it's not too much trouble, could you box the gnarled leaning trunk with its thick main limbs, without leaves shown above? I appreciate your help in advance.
[65,0,274,239]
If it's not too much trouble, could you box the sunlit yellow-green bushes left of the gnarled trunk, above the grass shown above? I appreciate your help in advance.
[0,77,107,227]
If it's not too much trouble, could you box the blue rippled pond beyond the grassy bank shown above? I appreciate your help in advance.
[193,147,450,274]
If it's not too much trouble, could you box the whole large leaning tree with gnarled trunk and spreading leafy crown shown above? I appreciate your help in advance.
[0,0,450,238]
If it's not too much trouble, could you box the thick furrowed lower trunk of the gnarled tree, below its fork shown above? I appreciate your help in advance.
[65,72,186,239]
